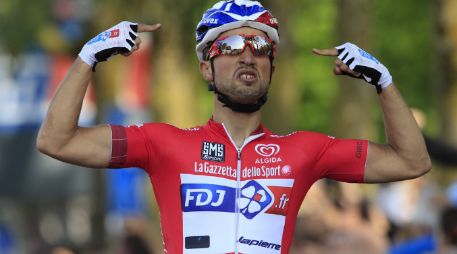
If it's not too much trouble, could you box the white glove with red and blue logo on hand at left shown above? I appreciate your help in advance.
[79,21,138,70]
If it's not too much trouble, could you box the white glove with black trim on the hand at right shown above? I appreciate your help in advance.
[336,42,392,93]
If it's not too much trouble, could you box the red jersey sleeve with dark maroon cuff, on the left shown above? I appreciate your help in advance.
[109,125,149,168]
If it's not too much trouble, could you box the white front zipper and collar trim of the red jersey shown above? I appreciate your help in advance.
[222,124,264,254]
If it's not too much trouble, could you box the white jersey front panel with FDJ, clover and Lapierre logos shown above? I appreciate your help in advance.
[181,174,294,254]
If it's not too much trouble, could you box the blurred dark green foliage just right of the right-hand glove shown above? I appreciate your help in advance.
[373,0,435,109]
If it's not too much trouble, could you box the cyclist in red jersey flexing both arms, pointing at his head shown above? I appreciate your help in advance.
[37,0,431,254]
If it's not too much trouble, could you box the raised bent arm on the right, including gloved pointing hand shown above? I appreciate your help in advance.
[313,43,432,183]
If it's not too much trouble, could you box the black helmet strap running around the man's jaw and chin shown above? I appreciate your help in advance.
[208,59,273,113]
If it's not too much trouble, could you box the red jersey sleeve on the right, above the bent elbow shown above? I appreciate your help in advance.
[316,137,368,183]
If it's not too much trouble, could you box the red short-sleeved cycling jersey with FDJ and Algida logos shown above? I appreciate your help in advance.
[111,120,368,254]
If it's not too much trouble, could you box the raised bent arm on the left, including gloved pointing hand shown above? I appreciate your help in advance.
[37,22,160,168]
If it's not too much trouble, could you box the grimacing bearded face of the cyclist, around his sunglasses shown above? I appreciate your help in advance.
[208,27,272,103]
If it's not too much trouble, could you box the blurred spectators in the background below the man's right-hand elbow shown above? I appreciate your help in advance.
[292,109,457,254]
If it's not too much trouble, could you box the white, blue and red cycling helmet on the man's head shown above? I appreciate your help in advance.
[195,0,279,61]
